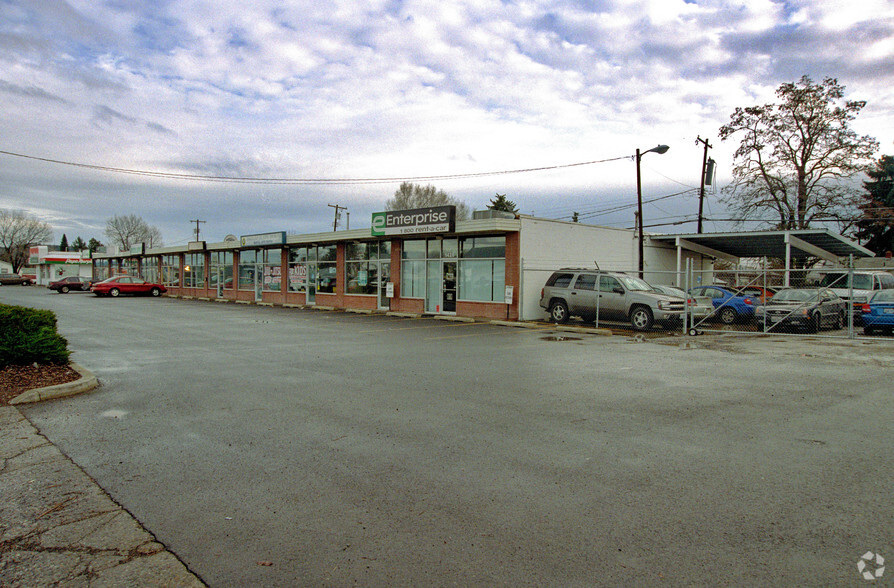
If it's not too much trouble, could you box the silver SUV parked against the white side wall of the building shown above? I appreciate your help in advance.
[540,268,686,331]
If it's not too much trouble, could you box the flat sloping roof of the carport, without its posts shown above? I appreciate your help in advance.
[649,229,875,258]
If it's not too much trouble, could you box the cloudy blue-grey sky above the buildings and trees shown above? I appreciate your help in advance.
[0,0,894,245]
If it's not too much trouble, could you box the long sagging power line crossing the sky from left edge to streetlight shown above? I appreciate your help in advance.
[0,150,630,185]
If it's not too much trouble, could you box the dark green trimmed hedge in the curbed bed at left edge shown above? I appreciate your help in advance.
[0,304,70,369]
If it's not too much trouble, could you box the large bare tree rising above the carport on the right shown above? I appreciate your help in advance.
[720,76,878,229]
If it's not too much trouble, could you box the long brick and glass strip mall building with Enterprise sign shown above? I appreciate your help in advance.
[93,207,711,320]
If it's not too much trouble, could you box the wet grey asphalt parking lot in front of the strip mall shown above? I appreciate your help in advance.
[0,287,894,586]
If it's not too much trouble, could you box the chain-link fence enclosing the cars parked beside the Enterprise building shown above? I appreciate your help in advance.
[546,263,894,339]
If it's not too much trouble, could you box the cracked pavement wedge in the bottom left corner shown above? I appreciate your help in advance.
[0,406,204,588]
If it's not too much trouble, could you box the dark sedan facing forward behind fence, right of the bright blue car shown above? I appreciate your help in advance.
[757,288,847,333]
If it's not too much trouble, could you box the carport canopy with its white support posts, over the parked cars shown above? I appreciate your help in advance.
[649,229,875,285]
